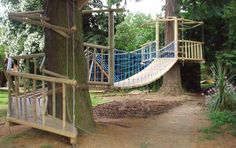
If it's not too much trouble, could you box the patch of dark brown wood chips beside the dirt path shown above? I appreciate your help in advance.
[93,100,182,119]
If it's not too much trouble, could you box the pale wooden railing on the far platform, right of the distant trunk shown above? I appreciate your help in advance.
[178,40,204,60]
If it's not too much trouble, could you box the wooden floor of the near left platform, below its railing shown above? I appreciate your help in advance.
[8,91,77,143]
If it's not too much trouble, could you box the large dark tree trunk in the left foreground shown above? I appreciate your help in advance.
[45,0,95,131]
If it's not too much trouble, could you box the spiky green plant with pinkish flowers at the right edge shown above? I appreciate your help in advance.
[206,62,236,111]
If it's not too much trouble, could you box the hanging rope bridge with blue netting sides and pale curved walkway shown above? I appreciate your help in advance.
[85,41,177,88]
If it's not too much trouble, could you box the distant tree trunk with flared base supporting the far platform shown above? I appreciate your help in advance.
[160,0,183,96]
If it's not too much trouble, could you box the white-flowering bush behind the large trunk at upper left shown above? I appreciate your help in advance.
[0,0,44,56]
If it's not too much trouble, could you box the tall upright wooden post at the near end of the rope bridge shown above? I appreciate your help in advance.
[108,11,115,87]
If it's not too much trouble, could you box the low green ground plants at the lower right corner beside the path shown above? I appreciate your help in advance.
[200,111,236,140]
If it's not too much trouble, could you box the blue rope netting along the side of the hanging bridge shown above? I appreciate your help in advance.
[90,41,175,82]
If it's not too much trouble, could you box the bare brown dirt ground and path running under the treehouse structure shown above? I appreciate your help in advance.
[0,94,236,148]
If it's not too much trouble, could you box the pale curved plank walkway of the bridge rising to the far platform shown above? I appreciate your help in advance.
[114,58,177,88]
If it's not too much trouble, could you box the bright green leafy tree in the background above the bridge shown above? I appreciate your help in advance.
[115,13,155,51]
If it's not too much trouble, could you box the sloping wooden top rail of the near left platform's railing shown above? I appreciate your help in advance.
[7,71,77,85]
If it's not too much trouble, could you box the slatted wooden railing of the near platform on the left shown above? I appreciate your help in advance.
[6,54,77,141]
